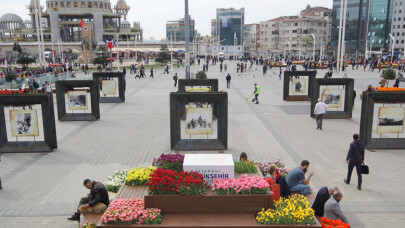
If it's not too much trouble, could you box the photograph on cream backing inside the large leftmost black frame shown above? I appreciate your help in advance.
[10,110,39,137]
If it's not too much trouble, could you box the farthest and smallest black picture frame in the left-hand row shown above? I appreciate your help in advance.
[93,72,125,103]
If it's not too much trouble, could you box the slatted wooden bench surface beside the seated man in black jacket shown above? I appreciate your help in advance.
[80,184,148,226]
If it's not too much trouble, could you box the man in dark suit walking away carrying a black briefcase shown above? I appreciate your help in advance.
[344,134,364,190]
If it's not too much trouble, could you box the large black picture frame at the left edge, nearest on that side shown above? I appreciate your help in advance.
[0,94,58,153]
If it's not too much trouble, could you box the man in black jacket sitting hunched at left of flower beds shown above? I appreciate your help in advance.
[68,179,110,221]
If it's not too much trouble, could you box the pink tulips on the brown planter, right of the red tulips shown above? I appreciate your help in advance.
[212,176,270,195]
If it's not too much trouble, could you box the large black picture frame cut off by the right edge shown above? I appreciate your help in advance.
[359,91,405,149]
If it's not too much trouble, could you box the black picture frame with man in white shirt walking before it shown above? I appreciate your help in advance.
[310,78,354,119]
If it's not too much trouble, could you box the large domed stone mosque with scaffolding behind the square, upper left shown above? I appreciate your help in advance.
[0,0,143,43]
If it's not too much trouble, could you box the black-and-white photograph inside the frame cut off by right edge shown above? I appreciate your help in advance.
[377,107,405,134]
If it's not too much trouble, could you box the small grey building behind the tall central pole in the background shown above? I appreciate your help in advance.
[166,17,197,42]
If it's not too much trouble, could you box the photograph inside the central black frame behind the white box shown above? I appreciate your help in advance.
[186,108,213,134]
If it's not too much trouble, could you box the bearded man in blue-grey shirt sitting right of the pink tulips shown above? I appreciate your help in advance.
[286,160,314,196]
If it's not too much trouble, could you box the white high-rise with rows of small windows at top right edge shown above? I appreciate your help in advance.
[390,0,405,59]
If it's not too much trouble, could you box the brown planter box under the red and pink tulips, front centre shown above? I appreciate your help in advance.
[145,189,273,214]
